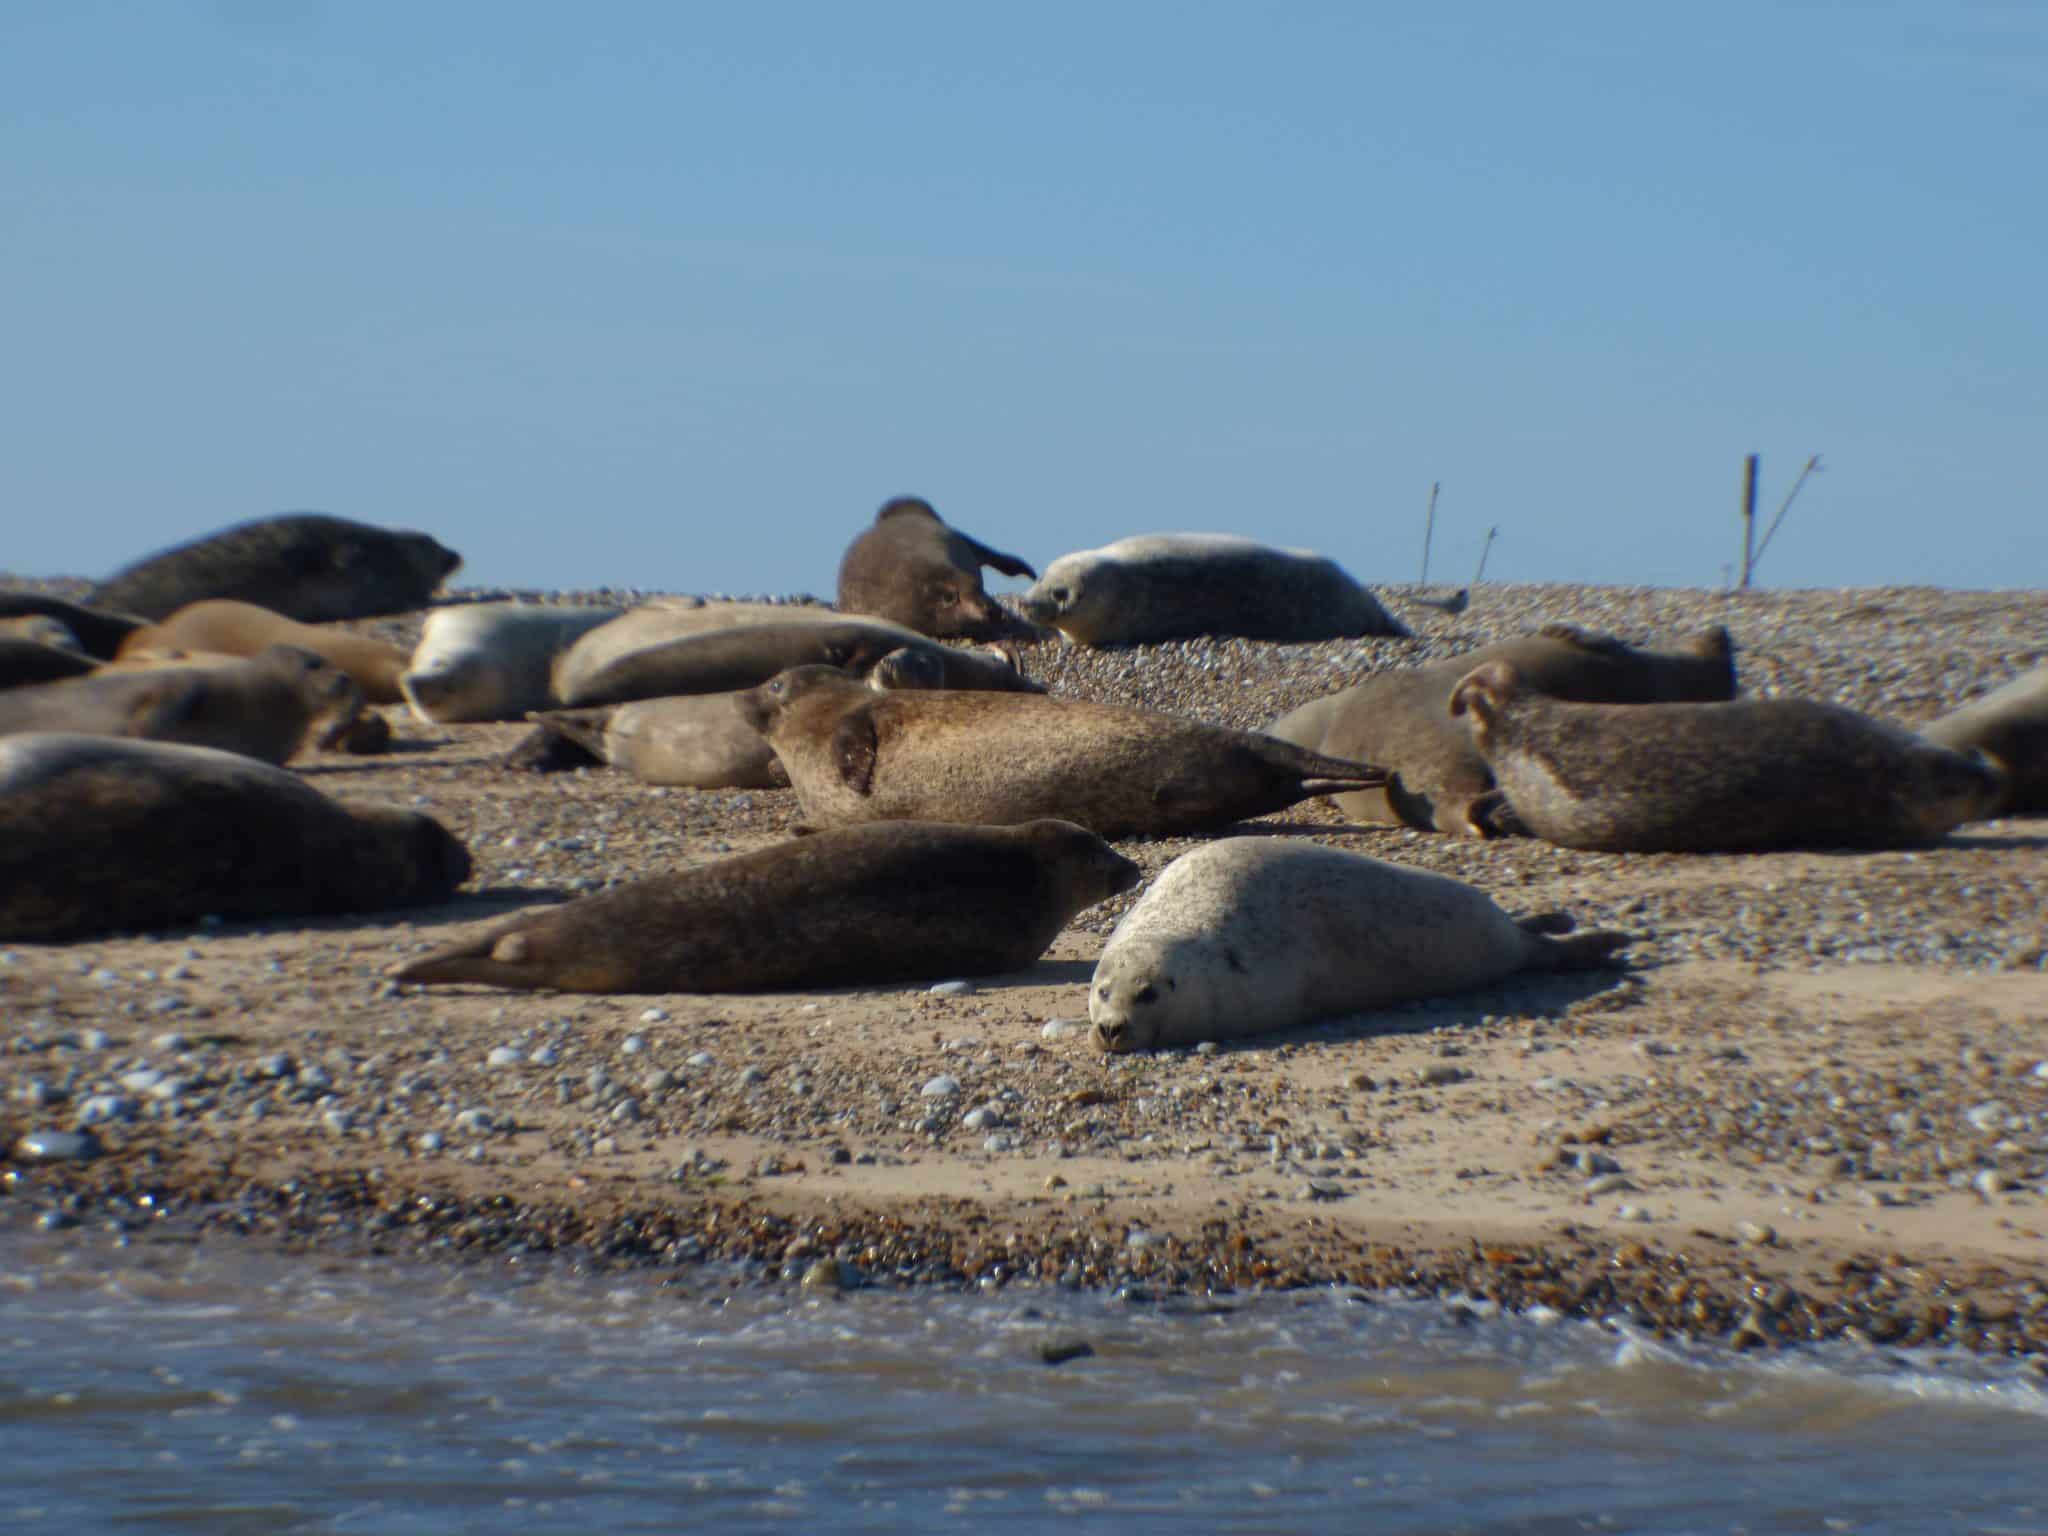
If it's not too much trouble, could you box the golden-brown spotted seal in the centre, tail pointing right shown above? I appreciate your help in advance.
[739,668,1386,838]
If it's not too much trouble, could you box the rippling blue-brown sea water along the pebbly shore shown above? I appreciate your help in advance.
[0,1231,2048,1536]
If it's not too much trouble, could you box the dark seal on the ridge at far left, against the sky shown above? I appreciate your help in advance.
[93,512,463,618]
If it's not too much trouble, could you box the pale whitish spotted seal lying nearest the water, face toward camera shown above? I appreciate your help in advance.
[1087,838,1628,1051]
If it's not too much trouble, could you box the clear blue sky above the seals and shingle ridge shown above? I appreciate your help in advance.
[0,0,2048,594]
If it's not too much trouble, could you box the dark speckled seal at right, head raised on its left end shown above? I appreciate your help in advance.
[1450,662,2005,852]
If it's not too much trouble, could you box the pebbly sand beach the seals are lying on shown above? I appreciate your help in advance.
[0,586,2048,1360]
